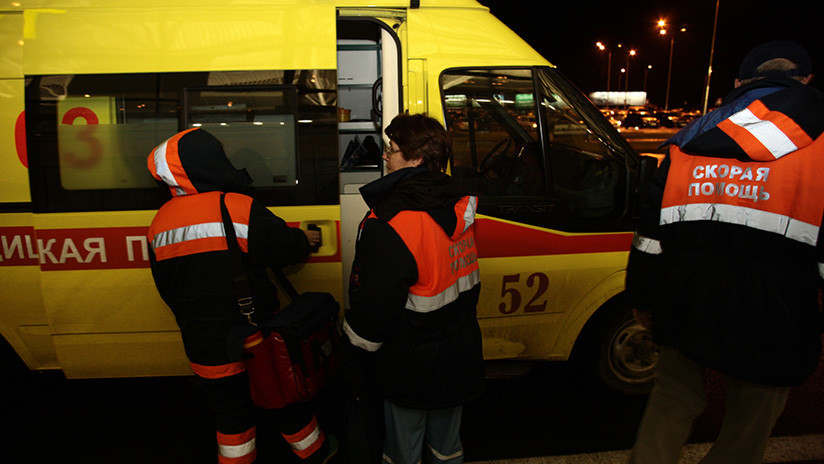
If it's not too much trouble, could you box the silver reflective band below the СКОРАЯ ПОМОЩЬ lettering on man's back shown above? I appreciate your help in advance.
[661,203,819,246]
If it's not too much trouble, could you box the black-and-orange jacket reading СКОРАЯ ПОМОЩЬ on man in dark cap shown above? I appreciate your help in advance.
[626,79,824,386]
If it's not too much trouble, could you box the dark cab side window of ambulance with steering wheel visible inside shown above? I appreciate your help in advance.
[441,68,627,231]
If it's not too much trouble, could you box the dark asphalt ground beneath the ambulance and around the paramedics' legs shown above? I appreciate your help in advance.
[0,346,824,464]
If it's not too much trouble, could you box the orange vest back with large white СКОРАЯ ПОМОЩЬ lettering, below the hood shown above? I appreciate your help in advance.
[660,138,824,246]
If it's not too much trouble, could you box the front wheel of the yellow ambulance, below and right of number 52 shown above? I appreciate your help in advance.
[579,302,658,395]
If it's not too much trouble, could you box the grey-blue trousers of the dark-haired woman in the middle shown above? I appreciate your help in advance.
[383,400,463,464]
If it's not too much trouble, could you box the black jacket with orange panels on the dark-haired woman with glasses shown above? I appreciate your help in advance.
[344,168,484,409]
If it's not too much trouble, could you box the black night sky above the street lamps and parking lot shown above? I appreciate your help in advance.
[479,0,824,109]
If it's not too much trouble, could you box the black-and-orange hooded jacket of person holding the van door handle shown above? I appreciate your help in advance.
[149,130,310,375]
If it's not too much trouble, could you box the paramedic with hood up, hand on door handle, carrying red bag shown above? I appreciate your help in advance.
[148,129,336,464]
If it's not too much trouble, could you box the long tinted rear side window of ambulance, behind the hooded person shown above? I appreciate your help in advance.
[26,70,338,212]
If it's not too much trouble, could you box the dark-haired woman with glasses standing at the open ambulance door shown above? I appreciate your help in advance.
[344,114,484,464]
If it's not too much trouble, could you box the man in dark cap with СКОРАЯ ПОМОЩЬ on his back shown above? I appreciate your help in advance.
[626,41,824,464]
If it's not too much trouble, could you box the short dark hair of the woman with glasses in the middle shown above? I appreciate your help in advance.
[386,113,452,171]
